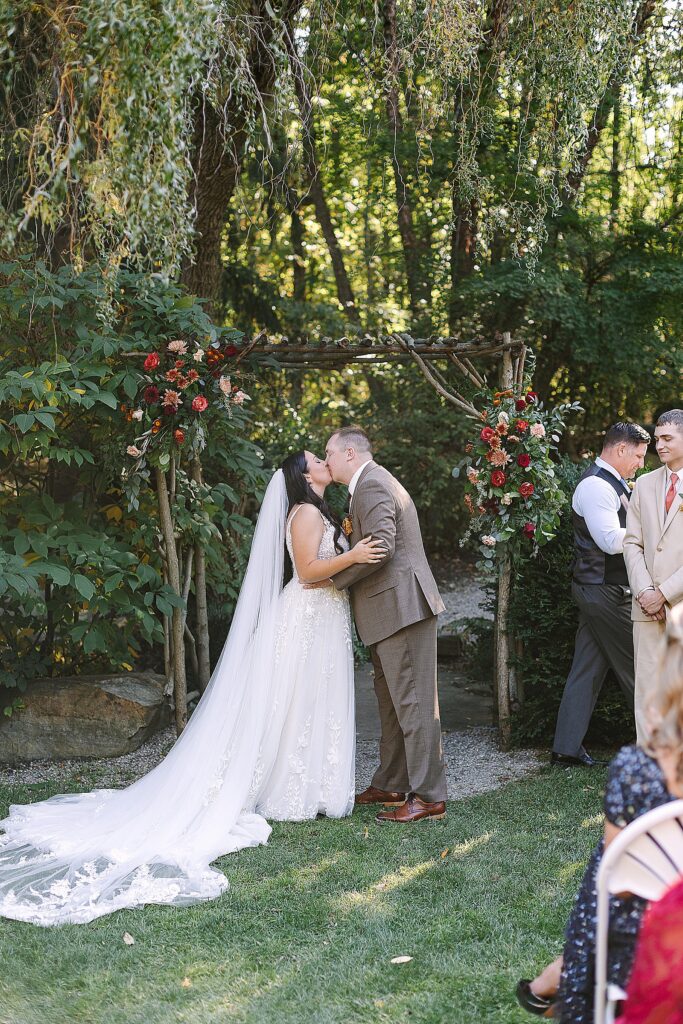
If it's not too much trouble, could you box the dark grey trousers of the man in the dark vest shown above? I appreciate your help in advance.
[553,583,634,757]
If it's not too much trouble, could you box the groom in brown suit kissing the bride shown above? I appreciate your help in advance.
[326,427,446,823]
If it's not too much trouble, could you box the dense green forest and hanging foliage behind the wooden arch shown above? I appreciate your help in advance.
[0,0,683,729]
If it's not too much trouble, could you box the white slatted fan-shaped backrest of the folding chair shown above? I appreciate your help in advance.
[598,800,683,900]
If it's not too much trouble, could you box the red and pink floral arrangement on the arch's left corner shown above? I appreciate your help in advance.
[120,338,249,466]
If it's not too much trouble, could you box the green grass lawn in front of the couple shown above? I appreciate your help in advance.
[0,769,605,1024]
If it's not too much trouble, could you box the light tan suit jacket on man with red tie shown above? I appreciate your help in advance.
[624,466,683,622]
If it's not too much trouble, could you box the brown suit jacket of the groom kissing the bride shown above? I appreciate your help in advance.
[332,460,444,646]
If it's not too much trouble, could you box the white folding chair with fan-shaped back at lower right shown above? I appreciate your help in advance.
[595,800,683,1024]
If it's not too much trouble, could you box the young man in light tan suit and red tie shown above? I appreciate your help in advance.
[624,409,683,743]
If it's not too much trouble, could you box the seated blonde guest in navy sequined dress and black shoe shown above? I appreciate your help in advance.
[517,604,683,1024]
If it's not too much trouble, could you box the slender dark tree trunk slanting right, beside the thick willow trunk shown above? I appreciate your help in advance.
[285,29,360,324]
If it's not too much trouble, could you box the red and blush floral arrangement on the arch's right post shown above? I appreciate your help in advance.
[454,387,581,569]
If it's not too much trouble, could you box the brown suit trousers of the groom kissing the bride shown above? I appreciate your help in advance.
[370,614,446,802]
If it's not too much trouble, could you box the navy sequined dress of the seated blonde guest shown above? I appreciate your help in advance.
[559,746,674,1024]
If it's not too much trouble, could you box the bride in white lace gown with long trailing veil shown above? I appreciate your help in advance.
[0,452,383,925]
